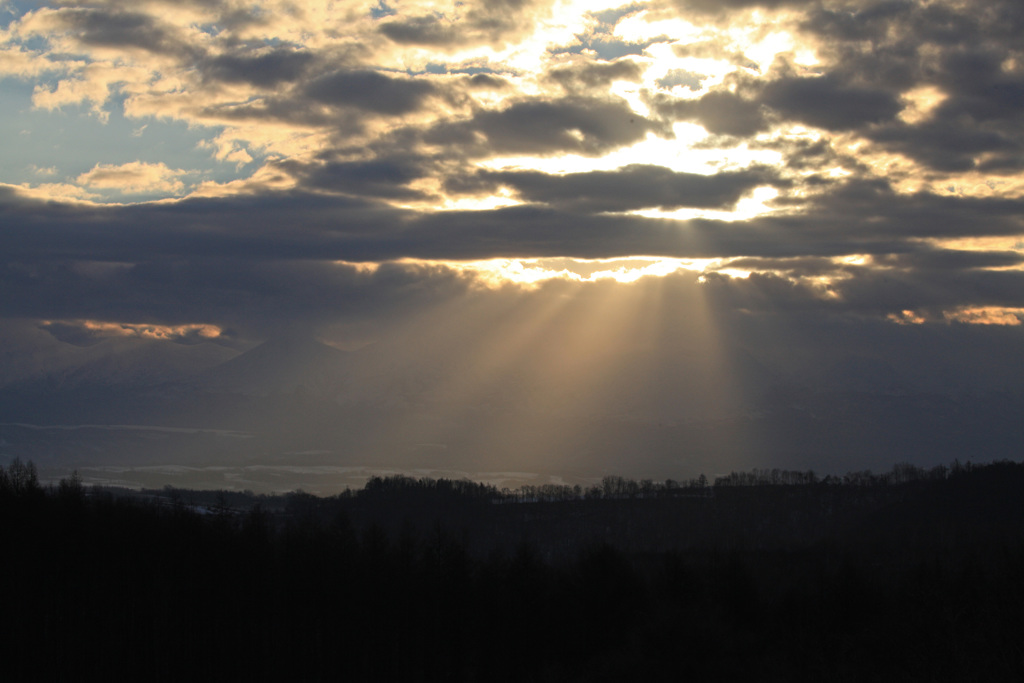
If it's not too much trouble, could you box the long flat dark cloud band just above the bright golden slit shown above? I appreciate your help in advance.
[0,187,770,266]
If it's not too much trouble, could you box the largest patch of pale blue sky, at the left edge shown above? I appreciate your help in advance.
[0,79,261,201]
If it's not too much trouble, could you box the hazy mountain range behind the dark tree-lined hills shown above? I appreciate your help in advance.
[0,327,1024,489]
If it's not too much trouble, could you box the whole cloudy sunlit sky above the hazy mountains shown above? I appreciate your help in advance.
[0,0,1024,481]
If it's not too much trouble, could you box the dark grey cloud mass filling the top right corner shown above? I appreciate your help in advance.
[794,0,1024,172]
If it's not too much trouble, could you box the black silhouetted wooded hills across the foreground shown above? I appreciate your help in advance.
[0,462,1024,681]
